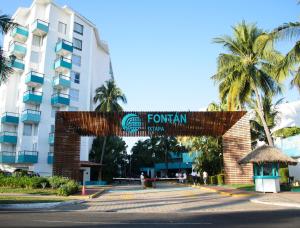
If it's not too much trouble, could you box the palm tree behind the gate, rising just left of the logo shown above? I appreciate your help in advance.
[94,79,127,180]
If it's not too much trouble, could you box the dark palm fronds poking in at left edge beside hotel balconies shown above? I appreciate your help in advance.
[0,14,17,85]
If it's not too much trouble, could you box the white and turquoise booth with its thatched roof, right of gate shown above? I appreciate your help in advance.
[239,145,297,193]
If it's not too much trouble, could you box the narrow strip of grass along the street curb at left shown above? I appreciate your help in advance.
[0,196,68,204]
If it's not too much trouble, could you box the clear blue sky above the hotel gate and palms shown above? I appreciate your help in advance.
[0,0,300,152]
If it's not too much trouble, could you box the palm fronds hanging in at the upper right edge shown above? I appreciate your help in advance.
[271,22,300,91]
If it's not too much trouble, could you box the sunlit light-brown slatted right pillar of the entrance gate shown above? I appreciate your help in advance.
[222,114,253,184]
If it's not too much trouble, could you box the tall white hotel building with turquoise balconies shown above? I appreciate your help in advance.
[0,0,113,180]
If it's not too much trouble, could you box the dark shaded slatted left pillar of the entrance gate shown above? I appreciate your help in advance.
[53,113,80,181]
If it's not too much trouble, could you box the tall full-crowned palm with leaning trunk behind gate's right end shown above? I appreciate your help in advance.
[212,21,283,145]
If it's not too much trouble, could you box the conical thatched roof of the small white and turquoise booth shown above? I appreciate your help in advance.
[239,145,297,165]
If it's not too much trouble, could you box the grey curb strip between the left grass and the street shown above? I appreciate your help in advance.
[0,200,84,209]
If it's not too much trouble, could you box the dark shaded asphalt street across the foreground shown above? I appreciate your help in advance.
[0,210,300,228]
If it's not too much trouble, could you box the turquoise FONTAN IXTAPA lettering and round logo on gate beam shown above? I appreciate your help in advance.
[121,112,188,135]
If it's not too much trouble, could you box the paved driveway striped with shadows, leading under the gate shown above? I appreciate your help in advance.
[61,184,283,213]
